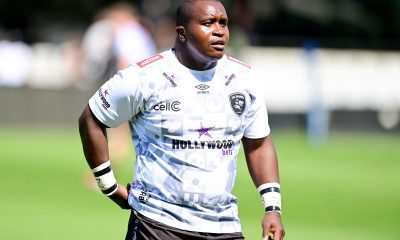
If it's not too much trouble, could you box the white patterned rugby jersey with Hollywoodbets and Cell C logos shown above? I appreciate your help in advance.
[89,49,270,233]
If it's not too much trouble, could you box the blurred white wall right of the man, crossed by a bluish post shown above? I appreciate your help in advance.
[240,47,400,113]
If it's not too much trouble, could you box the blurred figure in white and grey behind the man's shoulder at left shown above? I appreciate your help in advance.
[82,2,158,84]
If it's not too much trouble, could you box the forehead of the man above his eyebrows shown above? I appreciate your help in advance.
[191,0,227,18]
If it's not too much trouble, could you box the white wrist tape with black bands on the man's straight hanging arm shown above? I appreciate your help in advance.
[257,183,282,213]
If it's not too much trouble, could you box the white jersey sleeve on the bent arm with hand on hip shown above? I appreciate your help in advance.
[89,67,143,128]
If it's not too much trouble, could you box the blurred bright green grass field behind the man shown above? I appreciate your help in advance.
[0,128,400,240]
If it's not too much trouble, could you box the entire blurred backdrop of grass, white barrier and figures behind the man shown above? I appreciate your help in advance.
[0,0,400,240]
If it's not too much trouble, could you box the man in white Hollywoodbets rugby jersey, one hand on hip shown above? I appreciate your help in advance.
[79,0,284,240]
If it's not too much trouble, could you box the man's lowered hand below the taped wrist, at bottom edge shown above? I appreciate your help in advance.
[262,212,285,240]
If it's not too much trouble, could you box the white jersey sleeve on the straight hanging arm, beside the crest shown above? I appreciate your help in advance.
[243,71,270,139]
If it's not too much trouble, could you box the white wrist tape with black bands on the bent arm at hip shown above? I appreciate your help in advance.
[92,161,118,196]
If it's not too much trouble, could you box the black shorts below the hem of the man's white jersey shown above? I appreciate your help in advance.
[125,210,244,240]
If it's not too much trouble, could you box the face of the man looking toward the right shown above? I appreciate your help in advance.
[185,1,229,61]
